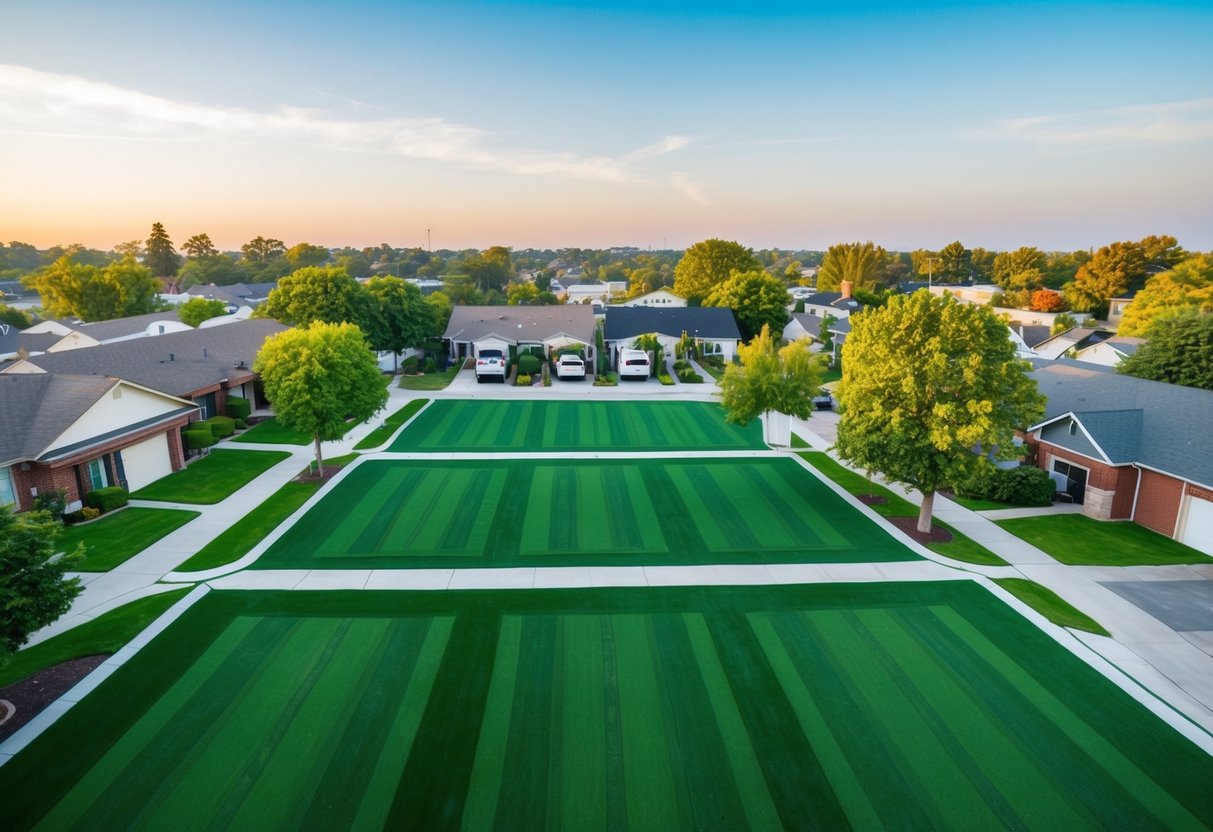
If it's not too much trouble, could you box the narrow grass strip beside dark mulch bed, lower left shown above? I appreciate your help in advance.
[0,586,194,688]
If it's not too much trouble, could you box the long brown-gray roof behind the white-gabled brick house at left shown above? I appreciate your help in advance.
[0,318,289,398]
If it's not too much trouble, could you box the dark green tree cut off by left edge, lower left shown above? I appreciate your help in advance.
[0,506,84,663]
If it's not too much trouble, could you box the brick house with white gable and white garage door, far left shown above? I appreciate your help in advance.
[0,372,198,511]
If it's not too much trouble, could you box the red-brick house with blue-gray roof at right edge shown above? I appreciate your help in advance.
[1027,360,1213,554]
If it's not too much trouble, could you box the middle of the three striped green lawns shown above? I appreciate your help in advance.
[255,457,917,569]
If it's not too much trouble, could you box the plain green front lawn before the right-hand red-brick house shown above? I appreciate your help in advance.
[998,514,1213,566]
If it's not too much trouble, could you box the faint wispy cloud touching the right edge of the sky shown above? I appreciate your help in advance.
[964,98,1213,146]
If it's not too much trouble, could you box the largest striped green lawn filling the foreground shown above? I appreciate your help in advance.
[0,582,1213,831]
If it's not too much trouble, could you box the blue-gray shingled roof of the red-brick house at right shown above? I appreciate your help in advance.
[1032,361,1213,486]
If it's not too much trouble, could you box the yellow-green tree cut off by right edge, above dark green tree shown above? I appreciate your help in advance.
[1116,310,1213,391]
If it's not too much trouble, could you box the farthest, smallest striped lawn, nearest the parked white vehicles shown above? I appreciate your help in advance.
[388,399,767,452]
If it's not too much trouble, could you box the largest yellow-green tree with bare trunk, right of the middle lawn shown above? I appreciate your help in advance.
[836,290,1044,532]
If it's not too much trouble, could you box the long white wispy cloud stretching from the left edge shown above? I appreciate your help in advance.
[0,64,691,187]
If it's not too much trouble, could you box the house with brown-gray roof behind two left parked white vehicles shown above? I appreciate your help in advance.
[443,303,594,365]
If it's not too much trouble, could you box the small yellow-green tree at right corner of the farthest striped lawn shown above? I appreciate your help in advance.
[721,325,821,446]
